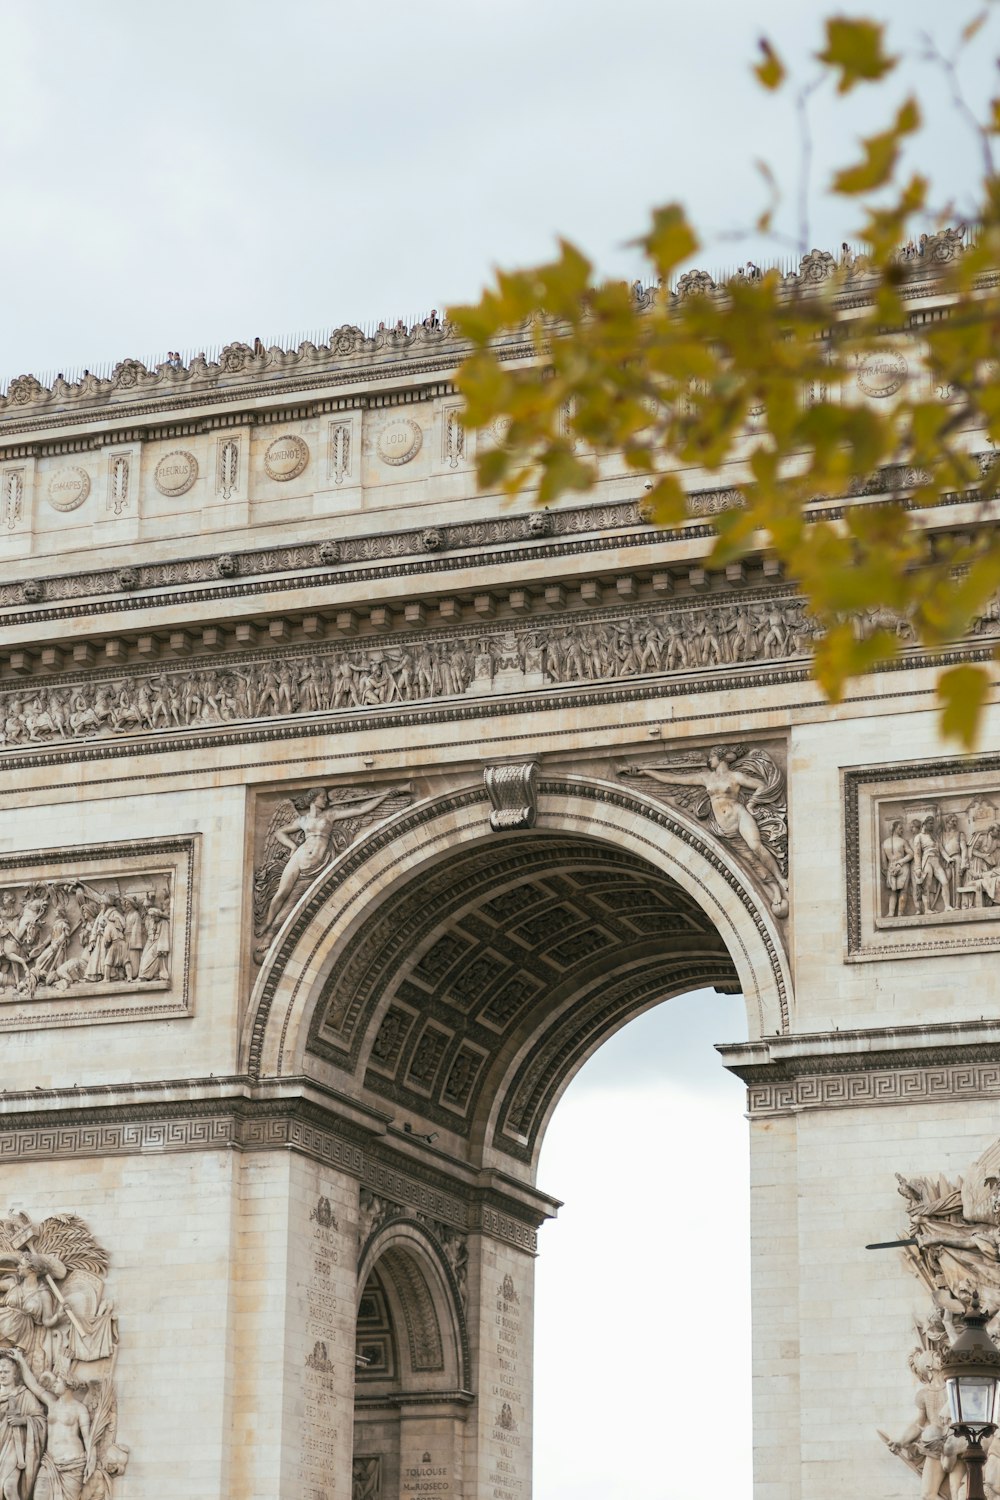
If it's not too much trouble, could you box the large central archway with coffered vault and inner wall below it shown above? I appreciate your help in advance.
[244,777,792,1500]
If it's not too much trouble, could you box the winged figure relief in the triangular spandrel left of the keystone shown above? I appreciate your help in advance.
[253,782,412,962]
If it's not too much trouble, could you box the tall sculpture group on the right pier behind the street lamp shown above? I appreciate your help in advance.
[880,1142,1000,1500]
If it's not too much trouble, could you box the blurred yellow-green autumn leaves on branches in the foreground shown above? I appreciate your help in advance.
[448,17,1000,747]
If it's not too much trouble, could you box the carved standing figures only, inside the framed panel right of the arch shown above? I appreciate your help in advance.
[879,797,1000,917]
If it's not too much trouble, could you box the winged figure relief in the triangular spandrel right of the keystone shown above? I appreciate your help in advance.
[619,744,789,918]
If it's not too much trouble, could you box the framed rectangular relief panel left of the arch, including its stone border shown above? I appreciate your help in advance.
[0,839,196,1031]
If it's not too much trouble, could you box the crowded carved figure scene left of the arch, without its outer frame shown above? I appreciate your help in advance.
[0,881,171,1002]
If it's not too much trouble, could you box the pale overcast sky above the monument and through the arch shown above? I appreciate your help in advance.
[0,0,997,1500]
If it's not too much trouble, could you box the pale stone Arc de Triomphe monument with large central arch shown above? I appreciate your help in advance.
[0,261,1000,1500]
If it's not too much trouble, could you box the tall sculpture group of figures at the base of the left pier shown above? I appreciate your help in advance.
[0,1214,129,1500]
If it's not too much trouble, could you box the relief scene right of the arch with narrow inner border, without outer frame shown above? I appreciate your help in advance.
[876,788,1000,927]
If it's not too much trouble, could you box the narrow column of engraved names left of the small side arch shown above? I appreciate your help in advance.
[298,1197,340,1497]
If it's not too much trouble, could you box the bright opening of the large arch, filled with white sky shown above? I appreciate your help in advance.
[534,992,753,1500]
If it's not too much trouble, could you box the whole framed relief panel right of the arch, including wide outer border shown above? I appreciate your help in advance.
[846,759,1000,959]
